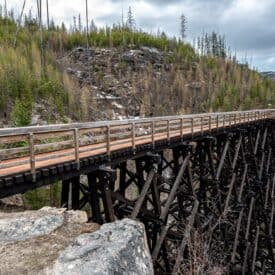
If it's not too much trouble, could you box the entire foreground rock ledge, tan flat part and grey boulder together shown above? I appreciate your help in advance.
[0,207,153,275]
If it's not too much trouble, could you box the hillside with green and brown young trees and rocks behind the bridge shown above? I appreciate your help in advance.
[0,14,275,126]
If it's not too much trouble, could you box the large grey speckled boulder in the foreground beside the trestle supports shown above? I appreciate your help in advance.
[46,219,154,275]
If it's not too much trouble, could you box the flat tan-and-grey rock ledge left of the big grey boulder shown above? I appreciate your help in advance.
[0,207,99,275]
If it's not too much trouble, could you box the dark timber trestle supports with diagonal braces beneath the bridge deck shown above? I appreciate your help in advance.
[62,122,275,274]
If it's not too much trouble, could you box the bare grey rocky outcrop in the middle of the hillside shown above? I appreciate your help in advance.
[58,47,171,120]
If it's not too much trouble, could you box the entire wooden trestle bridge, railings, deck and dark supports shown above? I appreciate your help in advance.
[0,110,275,274]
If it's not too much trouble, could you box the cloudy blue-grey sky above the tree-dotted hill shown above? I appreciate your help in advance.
[0,0,275,71]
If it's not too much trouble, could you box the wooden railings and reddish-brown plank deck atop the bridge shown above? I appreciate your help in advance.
[0,109,275,180]
